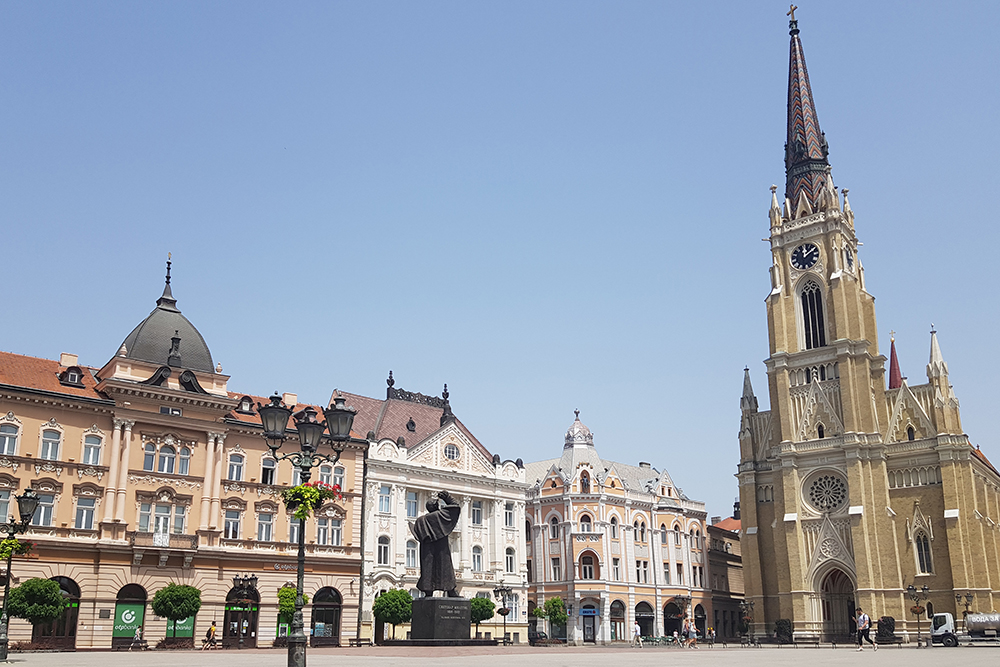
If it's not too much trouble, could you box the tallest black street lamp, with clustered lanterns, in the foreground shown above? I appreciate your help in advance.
[257,392,357,667]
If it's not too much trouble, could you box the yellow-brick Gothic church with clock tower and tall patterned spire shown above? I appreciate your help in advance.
[737,8,998,639]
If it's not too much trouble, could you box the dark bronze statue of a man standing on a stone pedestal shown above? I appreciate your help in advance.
[410,491,462,598]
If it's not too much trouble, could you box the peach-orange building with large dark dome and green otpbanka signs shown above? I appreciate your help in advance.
[0,265,368,648]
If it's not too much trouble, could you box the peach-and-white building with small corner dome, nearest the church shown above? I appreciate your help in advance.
[525,413,712,644]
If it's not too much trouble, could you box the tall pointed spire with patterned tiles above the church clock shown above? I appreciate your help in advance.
[785,5,833,218]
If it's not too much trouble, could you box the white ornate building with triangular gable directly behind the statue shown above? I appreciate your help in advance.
[349,373,528,643]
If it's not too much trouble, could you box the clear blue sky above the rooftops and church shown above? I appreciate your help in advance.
[0,1,1000,514]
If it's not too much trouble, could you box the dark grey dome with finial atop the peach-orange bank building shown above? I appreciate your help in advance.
[122,262,215,373]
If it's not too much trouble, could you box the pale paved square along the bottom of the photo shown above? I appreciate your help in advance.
[3,646,1000,667]
